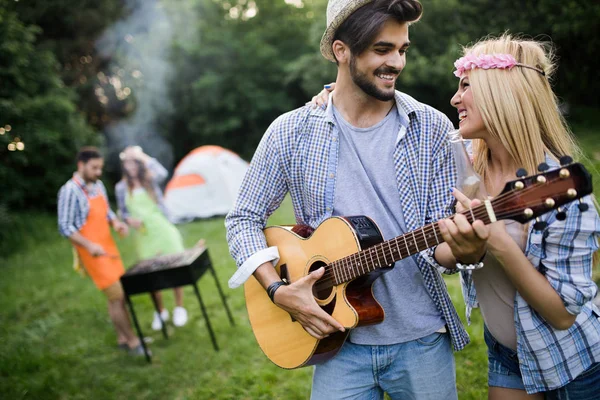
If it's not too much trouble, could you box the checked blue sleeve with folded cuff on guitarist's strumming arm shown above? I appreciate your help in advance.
[225,120,287,286]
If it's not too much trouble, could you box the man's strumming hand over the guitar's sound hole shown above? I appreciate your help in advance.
[273,267,345,339]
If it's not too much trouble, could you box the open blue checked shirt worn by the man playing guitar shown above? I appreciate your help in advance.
[225,92,469,350]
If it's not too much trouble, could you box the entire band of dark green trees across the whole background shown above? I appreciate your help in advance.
[0,0,600,214]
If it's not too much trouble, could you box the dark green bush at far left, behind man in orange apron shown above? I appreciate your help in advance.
[0,8,98,228]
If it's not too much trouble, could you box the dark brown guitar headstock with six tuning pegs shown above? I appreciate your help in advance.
[491,162,593,224]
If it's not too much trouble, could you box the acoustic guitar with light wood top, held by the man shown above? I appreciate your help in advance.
[244,156,592,369]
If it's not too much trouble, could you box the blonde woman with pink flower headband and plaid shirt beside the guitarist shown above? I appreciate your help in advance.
[315,35,600,399]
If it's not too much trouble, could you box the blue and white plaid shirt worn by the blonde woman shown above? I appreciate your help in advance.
[461,157,600,393]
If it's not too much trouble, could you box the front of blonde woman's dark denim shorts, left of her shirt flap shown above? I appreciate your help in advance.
[483,326,525,390]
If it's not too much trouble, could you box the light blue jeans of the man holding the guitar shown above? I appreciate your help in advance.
[310,333,457,400]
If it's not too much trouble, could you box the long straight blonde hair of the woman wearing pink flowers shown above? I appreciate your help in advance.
[464,34,582,180]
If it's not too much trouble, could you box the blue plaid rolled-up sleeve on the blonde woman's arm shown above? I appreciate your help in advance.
[540,196,600,315]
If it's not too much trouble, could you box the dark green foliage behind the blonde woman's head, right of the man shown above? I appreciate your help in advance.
[399,0,600,116]
